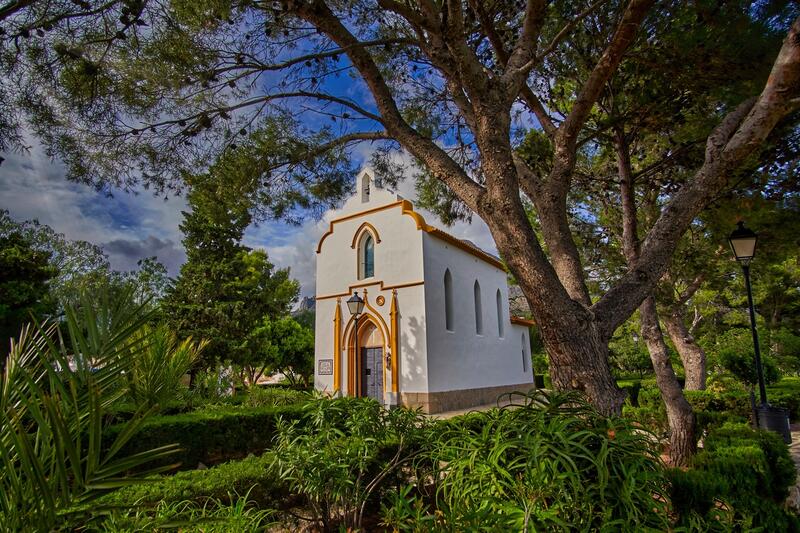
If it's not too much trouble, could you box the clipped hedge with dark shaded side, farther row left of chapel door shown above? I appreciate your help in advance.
[103,405,303,469]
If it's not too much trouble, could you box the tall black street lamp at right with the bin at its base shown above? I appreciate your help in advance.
[728,221,792,443]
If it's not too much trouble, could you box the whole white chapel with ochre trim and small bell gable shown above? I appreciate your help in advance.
[314,169,533,413]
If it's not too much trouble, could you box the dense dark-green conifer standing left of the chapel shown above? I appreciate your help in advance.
[164,162,299,367]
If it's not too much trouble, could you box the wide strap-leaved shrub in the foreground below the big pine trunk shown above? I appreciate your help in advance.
[383,391,668,531]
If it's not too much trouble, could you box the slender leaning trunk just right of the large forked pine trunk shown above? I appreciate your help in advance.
[639,296,697,466]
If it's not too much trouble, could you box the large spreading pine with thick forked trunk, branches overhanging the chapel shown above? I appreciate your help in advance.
[0,0,800,411]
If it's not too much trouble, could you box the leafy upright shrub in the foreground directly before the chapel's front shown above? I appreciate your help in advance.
[273,392,432,530]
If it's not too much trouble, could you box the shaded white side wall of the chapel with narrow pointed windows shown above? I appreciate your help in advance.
[423,233,533,392]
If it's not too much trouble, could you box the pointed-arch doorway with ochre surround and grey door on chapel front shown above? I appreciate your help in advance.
[347,314,386,403]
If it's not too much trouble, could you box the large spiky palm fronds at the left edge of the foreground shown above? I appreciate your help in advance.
[0,284,181,531]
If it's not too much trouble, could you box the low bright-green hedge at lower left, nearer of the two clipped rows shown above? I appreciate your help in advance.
[96,452,287,508]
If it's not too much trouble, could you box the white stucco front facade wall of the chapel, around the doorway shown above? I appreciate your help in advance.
[315,168,427,392]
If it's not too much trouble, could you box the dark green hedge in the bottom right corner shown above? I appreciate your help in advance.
[668,423,800,531]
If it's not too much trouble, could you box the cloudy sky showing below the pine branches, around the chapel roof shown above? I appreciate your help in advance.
[0,144,497,297]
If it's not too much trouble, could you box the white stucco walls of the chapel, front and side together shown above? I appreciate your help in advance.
[315,171,533,401]
